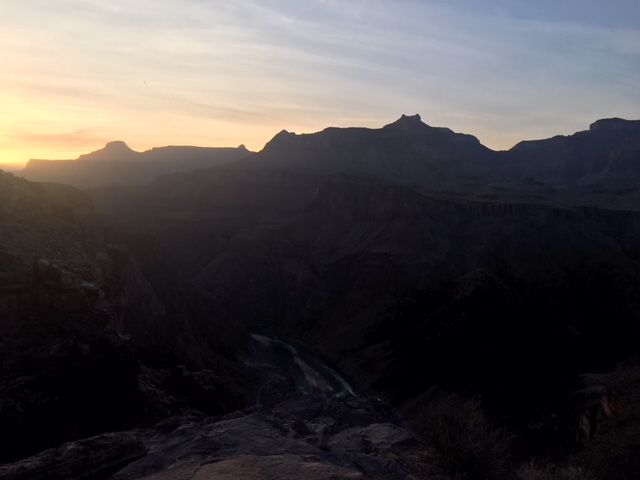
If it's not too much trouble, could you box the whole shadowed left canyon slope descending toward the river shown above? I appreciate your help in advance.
[0,172,250,461]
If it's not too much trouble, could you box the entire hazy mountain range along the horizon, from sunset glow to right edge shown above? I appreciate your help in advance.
[16,115,640,207]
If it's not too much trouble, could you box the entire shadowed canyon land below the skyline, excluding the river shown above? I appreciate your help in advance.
[0,115,640,479]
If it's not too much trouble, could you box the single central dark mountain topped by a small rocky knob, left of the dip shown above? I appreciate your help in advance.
[247,115,495,185]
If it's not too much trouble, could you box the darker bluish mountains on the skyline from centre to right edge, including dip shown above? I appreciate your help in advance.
[245,115,640,197]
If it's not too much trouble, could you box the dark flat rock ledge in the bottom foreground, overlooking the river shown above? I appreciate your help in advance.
[0,395,443,480]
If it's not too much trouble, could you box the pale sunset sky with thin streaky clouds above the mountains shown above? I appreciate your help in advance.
[0,0,640,168]
